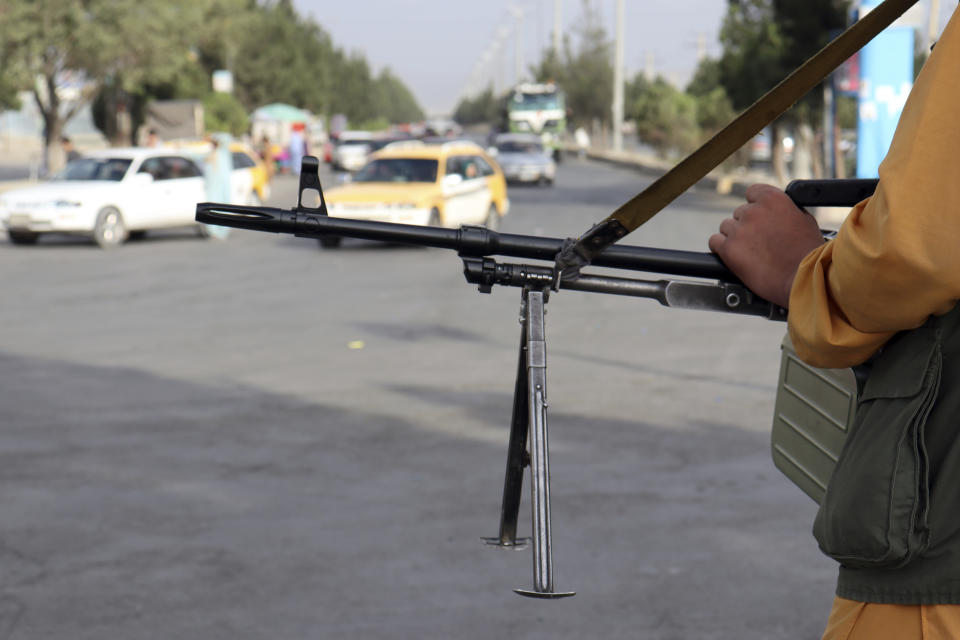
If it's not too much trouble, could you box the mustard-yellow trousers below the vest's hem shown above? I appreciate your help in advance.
[823,598,960,640]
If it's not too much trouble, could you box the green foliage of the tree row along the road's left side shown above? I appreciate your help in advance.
[0,0,423,158]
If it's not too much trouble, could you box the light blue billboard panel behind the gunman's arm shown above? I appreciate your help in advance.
[857,0,914,178]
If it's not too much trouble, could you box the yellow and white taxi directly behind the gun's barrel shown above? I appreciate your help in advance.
[320,141,510,247]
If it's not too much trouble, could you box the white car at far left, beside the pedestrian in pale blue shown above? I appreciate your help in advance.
[0,148,206,248]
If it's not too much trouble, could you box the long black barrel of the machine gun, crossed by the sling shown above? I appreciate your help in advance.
[196,202,739,283]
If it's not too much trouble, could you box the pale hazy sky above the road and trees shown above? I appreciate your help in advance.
[294,0,957,115]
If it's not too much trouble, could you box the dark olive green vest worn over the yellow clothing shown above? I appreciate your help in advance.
[813,305,960,604]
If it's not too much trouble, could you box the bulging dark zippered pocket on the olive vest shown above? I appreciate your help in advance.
[813,323,942,568]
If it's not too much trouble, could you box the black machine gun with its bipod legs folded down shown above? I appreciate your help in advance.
[196,156,875,598]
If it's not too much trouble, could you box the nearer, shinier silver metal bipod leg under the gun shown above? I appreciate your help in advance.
[514,288,574,598]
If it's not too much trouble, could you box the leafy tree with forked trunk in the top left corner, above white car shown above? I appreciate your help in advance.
[0,0,202,171]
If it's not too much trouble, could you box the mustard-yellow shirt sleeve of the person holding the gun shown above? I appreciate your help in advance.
[788,12,960,367]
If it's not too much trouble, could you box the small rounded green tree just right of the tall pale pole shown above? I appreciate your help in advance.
[629,78,699,157]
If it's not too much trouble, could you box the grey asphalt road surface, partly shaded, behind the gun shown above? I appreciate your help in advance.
[0,160,835,640]
